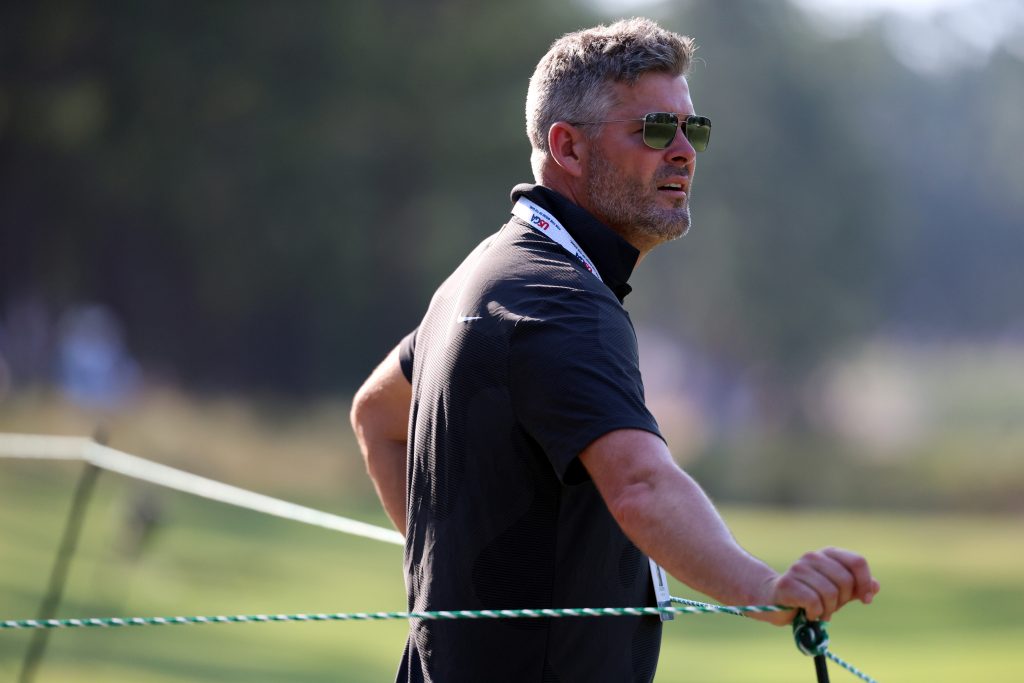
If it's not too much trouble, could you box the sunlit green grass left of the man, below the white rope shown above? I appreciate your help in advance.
[0,462,404,682]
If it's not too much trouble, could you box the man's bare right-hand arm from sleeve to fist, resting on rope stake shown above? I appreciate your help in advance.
[580,430,880,624]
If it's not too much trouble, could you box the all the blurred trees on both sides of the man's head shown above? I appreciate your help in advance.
[0,0,1024,401]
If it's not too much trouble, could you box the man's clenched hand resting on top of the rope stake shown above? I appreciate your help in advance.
[758,548,881,626]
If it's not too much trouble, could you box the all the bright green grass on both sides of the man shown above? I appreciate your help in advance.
[0,460,1024,683]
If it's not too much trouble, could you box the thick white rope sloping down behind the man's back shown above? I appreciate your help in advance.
[0,434,406,546]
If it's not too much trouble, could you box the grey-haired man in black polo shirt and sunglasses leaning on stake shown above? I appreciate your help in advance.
[352,19,879,683]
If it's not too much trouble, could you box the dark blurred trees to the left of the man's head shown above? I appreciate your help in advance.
[0,0,593,391]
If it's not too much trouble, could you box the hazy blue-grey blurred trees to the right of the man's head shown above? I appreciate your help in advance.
[638,0,1024,426]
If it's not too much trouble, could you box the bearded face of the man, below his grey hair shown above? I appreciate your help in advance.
[582,74,696,252]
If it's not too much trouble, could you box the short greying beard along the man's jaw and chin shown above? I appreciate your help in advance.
[587,147,690,244]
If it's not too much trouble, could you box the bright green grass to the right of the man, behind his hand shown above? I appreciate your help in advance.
[658,509,1024,682]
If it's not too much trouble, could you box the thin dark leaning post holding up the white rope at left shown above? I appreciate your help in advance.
[17,463,99,683]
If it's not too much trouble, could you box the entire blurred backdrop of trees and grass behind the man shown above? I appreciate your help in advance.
[0,0,1024,682]
